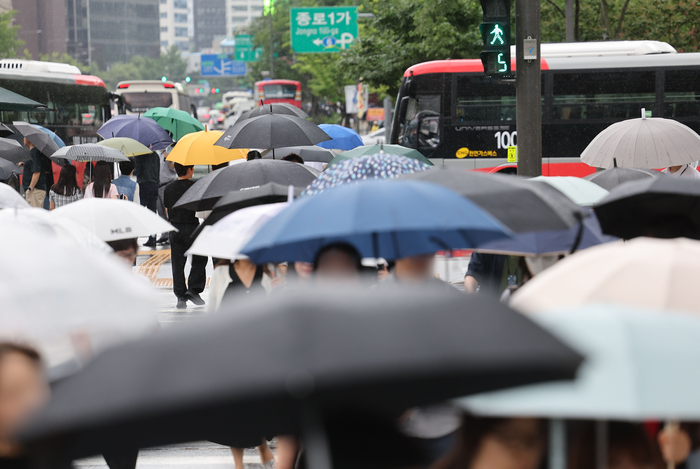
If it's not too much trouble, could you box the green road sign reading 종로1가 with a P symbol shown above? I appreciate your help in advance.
[290,7,359,54]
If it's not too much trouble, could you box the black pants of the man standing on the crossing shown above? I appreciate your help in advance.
[170,225,209,298]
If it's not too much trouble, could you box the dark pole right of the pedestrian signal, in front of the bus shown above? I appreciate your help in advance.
[515,0,542,177]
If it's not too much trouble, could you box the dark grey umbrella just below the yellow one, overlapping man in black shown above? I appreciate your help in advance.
[175,160,319,210]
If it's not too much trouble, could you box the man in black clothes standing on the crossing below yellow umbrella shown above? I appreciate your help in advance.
[163,163,209,309]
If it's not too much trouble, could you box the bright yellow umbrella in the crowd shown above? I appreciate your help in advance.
[166,130,248,166]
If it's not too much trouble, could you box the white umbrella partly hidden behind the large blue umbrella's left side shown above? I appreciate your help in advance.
[187,202,289,259]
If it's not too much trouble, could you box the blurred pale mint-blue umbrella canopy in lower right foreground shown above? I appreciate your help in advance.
[459,305,700,421]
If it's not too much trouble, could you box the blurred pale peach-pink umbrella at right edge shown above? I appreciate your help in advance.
[510,238,700,313]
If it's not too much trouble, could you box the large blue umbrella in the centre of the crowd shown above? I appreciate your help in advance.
[242,181,510,264]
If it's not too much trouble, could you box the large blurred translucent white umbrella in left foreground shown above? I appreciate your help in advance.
[0,221,158,378]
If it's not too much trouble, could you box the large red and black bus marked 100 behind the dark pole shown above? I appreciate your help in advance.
[389,41,700,176]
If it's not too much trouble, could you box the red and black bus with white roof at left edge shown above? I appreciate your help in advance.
[0,59,111,145]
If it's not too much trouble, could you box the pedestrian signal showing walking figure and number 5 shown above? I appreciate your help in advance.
[479,0,513,78]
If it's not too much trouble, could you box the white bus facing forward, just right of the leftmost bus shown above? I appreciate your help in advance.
[114,80,197,117]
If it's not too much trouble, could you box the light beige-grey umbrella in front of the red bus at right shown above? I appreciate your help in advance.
[581,117,700,169]
